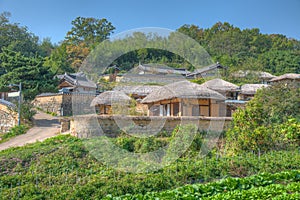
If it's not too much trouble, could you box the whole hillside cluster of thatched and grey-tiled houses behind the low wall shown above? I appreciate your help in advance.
[0,63,300,125]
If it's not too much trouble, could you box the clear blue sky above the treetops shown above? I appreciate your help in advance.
[0,0,300,43]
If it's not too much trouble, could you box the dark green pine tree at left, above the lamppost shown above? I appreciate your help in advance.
[0,49,57,99]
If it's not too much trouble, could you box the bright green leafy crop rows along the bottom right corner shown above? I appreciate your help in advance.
[108,170,300,200]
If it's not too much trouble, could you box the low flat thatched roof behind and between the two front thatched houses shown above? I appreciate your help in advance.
[114,85,161,96]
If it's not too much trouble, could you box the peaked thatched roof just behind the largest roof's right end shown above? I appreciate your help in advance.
[201,78,239,92]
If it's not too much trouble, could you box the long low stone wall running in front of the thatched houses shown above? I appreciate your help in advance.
[70,115,232,138]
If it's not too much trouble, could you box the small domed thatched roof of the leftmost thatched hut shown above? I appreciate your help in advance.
[91,91,131,106]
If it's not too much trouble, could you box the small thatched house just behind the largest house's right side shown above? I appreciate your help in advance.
[201,78,240,100]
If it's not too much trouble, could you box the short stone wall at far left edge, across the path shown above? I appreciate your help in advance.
[0,104,18,133]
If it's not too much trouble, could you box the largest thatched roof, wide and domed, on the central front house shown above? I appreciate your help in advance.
[142,81,225,103]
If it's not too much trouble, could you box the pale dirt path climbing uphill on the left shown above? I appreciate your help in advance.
[0,111,60,151]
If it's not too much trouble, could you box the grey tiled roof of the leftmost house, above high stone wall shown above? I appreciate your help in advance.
[56,72,97,88]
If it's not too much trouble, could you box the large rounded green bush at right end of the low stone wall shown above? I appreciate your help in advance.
[227,83,300,153]
